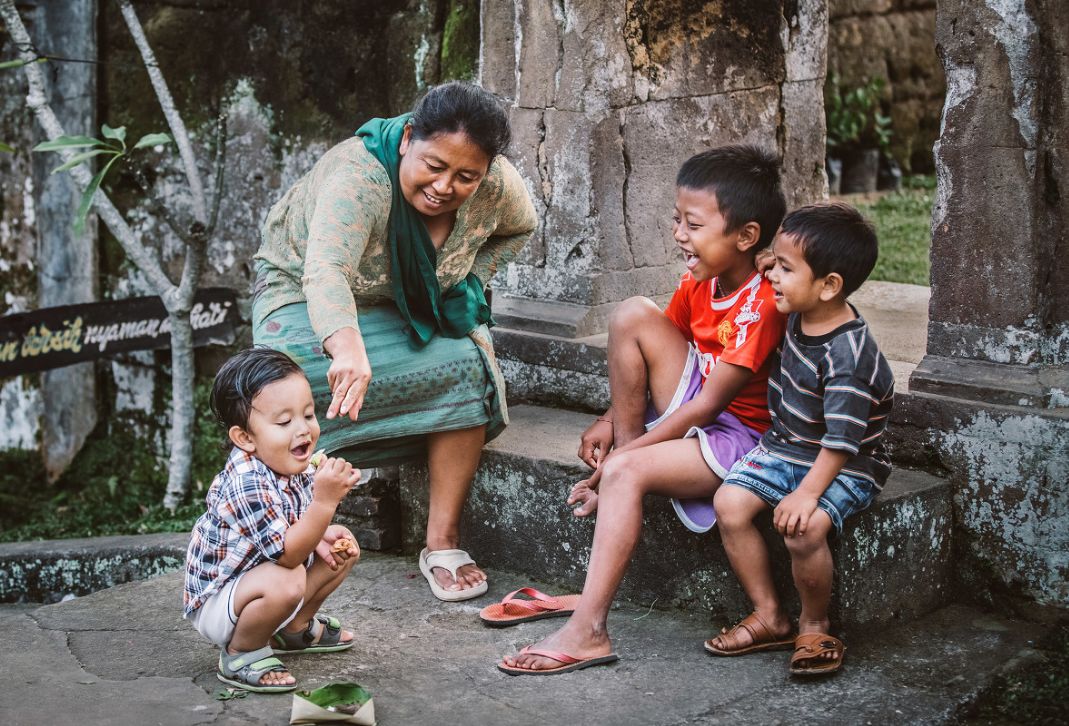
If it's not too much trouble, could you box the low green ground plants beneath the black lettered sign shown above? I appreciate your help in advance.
[0,383,226,541]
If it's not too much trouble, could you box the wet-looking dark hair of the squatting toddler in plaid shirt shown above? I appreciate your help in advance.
[212,345,305,431]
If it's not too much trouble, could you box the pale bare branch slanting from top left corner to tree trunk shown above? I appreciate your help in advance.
[0,0,176,297]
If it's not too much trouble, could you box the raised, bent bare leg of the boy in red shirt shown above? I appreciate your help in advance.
[608,297,688,447]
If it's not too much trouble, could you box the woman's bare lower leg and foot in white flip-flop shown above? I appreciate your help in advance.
[427,426,486,590]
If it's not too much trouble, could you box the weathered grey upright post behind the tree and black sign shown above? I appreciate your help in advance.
[31,0,98,478]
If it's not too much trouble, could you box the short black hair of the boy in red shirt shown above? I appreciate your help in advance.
[676,143,787,254]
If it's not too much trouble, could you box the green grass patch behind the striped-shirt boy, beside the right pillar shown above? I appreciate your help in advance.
[856,176,935,285]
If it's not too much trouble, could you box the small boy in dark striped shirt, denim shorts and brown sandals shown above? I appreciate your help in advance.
[706,204,895,676]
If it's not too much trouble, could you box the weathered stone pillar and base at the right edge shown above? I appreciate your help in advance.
[910,0,1069,607]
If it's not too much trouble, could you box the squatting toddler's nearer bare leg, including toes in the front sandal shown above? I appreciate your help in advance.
[227,562,305,685]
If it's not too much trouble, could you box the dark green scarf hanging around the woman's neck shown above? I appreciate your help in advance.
[356,113,494,347]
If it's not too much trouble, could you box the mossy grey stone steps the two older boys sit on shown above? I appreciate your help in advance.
[386,282,952,629]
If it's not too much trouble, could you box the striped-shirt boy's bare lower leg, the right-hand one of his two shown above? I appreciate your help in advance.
[784,509,835,660]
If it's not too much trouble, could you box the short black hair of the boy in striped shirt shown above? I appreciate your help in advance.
[779,202,879,297]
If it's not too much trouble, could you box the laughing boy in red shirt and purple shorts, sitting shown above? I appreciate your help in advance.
[498,145,786,675]
